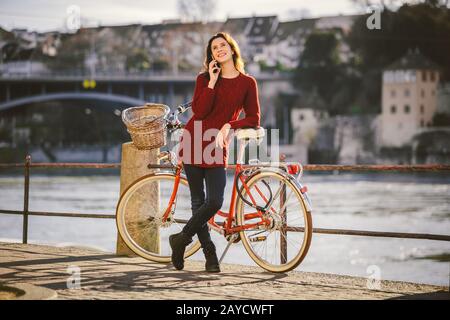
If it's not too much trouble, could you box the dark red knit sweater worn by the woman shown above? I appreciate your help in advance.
[179,73,260,168]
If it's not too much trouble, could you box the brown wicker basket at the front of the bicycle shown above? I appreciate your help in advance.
[122,103,170,150]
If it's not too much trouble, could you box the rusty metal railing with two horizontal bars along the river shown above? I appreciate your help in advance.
[0,155,450,244]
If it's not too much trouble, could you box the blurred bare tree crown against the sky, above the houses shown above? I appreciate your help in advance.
[177,0,216,22]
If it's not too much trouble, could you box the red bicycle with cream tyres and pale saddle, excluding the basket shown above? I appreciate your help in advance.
[116,104,312,272]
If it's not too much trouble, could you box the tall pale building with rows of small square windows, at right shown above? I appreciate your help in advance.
[380,49,439,147]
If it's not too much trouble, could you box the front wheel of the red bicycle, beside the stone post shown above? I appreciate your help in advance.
[116,173,201,262]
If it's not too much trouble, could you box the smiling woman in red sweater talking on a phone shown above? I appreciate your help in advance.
[169,32,260,272]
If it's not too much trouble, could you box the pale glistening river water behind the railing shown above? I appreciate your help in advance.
[0,171,450,286]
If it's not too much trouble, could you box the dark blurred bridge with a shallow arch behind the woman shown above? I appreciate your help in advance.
[0,72,289,111]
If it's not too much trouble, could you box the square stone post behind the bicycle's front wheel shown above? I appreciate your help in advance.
[116,142,160,256]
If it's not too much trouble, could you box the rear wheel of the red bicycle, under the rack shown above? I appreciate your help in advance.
[236,171,312,272]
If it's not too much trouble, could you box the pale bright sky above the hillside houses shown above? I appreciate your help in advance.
[0,0,363,32]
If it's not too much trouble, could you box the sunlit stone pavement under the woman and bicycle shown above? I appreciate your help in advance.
[0,242,450,300]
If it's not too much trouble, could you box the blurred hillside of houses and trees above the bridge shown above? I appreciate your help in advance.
[0,16,356,74]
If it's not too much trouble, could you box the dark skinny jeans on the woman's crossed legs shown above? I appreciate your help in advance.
[183,163,226,247]
